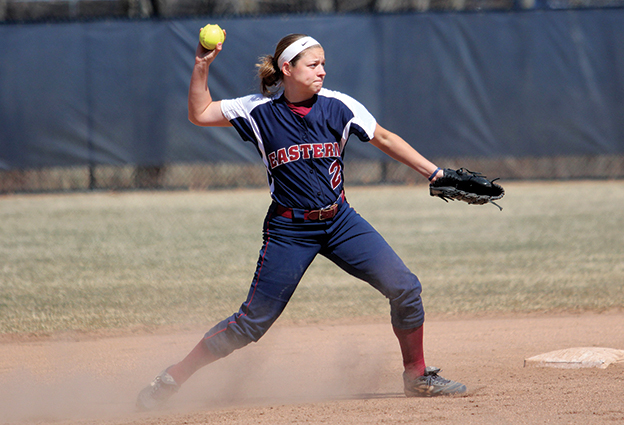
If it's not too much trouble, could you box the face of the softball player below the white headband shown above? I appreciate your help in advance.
[285,46,326,100]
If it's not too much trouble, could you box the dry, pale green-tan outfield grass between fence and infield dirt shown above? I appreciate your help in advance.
[0,181,624,333]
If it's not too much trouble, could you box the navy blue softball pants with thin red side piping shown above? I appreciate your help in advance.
[204,197,424,357]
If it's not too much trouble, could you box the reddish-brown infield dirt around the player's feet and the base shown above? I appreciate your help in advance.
[0,312,624,425]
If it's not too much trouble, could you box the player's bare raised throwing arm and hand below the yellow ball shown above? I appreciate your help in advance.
[188,39,231,127]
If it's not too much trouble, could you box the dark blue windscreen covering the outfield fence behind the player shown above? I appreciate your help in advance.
[0,9,624,169]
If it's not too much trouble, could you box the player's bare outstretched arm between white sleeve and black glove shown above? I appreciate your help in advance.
[370,124,444,180]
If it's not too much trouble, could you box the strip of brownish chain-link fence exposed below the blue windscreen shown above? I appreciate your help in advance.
[0,155,624,194]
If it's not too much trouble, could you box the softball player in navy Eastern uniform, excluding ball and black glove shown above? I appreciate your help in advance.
[137,34,466,410]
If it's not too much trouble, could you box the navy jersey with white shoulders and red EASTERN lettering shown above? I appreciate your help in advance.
[221,89,377,210]
